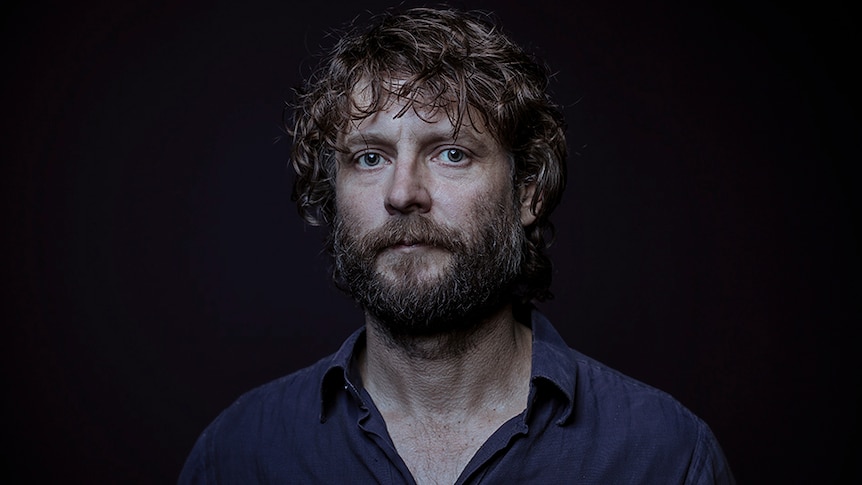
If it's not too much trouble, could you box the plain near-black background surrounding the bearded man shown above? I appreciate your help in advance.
[0,0,862,483]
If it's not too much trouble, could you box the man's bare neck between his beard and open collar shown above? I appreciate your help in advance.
[360,306,532,418]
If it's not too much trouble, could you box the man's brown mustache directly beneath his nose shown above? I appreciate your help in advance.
[360,216,467,254]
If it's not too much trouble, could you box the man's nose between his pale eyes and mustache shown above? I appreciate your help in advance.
[385,157,431,215]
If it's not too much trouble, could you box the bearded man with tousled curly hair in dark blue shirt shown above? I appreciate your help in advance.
[180,5,733,484]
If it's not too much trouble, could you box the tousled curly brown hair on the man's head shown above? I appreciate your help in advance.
[285,8,566,303]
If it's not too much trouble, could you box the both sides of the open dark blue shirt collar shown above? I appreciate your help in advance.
[320,309,576,425]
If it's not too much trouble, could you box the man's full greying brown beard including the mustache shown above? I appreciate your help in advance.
[332,197,525,340]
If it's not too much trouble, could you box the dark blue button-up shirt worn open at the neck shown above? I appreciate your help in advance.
[179,311,734,485]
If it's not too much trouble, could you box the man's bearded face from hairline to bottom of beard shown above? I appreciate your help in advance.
[333,92,534,335]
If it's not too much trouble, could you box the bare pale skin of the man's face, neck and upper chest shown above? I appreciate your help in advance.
[336,93,535,484]
